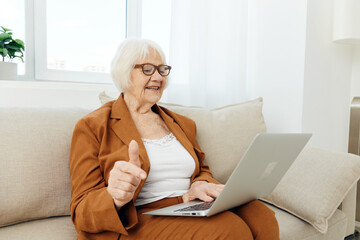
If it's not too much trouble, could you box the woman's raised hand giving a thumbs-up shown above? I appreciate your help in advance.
[107,140,147,211]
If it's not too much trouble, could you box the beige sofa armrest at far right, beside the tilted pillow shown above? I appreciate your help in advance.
[339,184,357,236]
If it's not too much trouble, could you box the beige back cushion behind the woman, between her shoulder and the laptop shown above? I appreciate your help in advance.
[99,93,266,183]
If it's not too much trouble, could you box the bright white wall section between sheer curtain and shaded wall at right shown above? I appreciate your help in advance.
[247,0,306,132]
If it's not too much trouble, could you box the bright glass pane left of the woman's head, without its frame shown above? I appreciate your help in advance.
[46,0,126,73]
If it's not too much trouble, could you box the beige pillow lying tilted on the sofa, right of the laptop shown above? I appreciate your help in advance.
[263,147,360,233]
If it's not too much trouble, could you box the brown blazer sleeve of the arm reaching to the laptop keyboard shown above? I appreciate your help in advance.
[191,122,220,184]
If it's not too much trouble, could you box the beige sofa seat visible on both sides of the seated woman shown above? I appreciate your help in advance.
[0,204,347,240]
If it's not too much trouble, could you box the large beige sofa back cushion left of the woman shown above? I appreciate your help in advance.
[0,108,89,226]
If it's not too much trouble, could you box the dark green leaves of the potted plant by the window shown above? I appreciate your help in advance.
[0,26,25,62]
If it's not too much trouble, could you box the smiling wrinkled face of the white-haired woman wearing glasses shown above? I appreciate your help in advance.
[126,49,167,104]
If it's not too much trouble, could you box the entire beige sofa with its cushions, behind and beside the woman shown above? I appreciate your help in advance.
[0,99,360,240]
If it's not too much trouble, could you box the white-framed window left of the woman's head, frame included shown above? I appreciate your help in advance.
[34,0,127,83]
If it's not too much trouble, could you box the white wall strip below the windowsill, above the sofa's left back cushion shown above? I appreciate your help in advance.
[0,80,118,109]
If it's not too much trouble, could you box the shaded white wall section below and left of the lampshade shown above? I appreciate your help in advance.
[302,0,353,152]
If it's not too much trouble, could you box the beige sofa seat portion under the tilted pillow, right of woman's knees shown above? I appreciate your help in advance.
[265,203,347,240]
